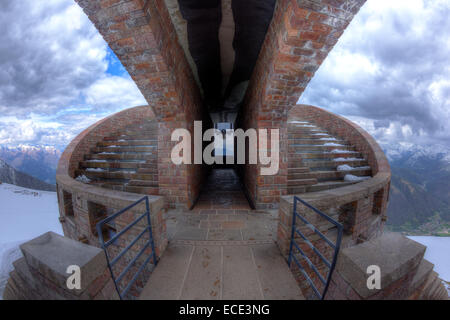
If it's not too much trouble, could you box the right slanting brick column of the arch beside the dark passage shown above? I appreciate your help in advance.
[243,0,365,208]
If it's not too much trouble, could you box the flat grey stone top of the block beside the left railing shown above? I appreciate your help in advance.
[20,232,107,295]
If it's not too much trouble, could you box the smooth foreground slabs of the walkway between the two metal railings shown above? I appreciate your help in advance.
[140,242,304,300]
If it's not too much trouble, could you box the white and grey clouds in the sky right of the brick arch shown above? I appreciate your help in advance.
[299,0,450,149]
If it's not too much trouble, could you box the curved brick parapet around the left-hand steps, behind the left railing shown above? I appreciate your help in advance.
[56,106,167,276]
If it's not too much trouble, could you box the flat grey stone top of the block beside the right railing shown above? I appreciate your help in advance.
[335,232,426,298]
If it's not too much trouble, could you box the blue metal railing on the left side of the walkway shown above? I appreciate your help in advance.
[97,197,157,299]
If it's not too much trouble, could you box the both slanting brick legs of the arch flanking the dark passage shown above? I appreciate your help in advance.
[76,0,365,207]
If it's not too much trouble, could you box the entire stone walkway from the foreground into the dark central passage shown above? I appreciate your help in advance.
[140,169,303,300]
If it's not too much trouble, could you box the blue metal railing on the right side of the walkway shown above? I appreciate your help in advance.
[288,197,344,300]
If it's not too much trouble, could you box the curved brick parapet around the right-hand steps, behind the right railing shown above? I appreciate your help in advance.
[277,105,391,293]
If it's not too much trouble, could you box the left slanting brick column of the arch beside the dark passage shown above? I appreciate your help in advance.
[76,0,203,207]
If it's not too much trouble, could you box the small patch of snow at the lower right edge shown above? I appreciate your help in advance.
[408,236,450,294]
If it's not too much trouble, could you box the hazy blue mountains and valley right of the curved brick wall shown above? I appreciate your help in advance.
[384,144,450,236]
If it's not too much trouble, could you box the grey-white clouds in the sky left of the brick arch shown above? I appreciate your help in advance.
[0,0,146,146]
